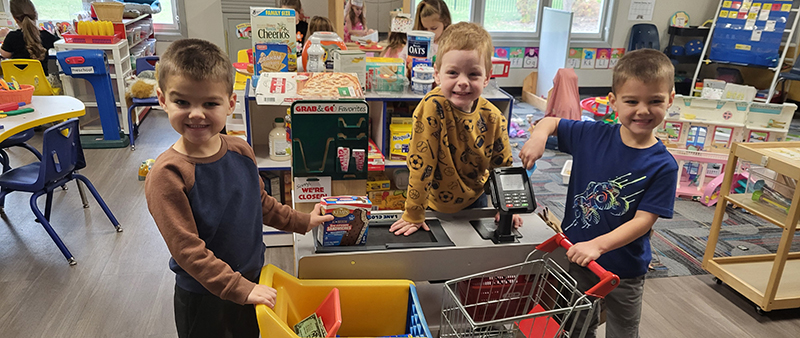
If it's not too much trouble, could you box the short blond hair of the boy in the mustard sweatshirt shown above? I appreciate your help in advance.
[436,22,494,77]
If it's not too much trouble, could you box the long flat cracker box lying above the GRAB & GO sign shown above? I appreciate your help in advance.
[255,72,364,106]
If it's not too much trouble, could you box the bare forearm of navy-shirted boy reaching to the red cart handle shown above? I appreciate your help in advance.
[567,210,658,266]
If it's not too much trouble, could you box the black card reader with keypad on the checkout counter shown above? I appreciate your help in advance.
[470,167,536,244]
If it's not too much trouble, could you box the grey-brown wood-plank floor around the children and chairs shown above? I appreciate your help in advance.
[0,112,800,338]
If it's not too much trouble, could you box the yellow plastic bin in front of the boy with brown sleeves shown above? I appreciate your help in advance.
[256,264,433,338]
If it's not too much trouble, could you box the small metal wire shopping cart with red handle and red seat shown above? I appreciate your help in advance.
[439,233,619,338]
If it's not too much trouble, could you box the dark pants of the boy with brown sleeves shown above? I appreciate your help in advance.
[174,285,258,338]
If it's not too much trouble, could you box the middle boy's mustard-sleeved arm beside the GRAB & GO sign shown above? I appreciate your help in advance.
[403,96,447,224]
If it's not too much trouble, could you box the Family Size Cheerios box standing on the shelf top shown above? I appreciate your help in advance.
[250,7,297,72]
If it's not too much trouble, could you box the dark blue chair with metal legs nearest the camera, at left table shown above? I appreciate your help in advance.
[0,119,122,265]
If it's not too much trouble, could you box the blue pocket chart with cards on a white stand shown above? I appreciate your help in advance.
[690,0,798,102]
